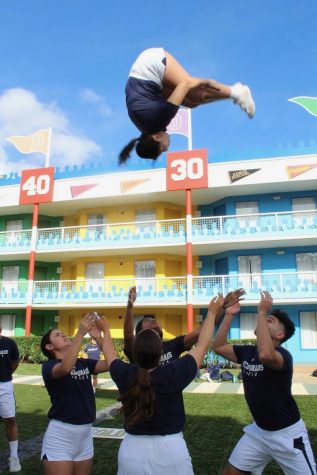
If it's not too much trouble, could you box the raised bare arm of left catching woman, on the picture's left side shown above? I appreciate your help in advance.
[52,313,95,378]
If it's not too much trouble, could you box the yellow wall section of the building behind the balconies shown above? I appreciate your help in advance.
[58,202,198,338]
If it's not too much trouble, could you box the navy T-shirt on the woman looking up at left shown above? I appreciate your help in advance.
[42,358,97,425]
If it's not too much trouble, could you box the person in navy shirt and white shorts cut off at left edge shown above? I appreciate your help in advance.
[0,321,21,473]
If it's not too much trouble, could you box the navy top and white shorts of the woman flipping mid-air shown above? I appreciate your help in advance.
[125,48,179,134]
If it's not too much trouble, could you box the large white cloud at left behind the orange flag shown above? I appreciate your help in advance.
[0,88,101,174]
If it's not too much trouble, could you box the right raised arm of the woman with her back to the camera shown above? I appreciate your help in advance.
[189,295,224,368]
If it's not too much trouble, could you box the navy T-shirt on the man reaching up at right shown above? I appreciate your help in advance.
[233,345,300,431]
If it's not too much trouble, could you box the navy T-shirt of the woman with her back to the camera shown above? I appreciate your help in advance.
[110,354,197,435]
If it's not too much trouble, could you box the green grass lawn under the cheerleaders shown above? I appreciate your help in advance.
[0,385,317,475]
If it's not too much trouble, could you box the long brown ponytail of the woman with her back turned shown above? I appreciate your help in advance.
[118,368,155,429]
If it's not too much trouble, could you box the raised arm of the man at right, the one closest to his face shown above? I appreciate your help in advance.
[256,291,284,370]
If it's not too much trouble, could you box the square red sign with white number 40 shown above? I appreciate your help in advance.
[20,167,54,205]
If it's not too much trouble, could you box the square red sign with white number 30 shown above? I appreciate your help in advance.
[166,148,208,191]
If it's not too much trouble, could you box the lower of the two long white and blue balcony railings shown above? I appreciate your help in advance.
[0,272,317,307]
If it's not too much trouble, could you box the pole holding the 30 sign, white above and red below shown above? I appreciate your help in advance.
[186,108,194,333]
